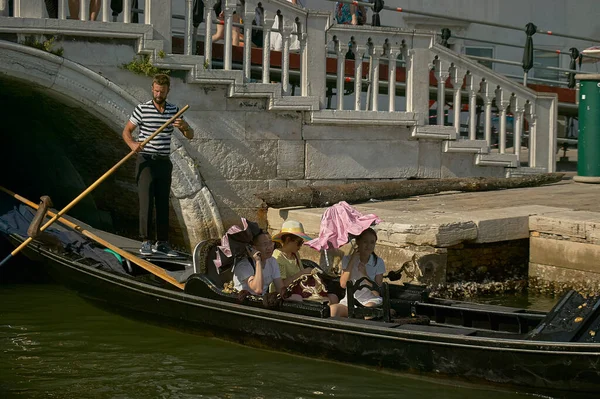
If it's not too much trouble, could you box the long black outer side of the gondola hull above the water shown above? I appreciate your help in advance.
[4,236,600,397]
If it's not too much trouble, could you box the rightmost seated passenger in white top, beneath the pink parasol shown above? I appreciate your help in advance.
[331,228,385,317]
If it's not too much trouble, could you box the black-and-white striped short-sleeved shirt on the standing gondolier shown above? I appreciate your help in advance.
[129,100,179,155]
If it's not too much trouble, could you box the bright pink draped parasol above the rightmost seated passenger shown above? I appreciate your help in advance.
[306,201,381,251]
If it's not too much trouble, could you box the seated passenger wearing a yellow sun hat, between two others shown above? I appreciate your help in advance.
[271,220,338,304]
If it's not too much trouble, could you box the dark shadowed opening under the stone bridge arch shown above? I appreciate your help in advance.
[0,79,164,242]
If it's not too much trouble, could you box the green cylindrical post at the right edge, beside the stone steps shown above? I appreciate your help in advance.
[573,74,600,183]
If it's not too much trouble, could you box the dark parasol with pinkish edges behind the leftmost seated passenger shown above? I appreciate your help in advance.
[213,218,261,270]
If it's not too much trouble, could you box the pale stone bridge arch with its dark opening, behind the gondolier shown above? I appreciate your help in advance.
[0,41,223,246]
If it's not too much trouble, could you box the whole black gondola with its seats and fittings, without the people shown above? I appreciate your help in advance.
[0,196,600,397]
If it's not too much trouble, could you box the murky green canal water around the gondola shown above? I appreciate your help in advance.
[0,264,564,399]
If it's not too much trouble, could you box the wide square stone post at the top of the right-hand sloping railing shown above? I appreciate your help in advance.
[406,48,430,126]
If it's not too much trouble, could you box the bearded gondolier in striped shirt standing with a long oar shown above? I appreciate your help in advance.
[123,74,194,256]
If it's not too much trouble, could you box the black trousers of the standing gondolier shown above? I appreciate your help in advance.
[136,154,173,241]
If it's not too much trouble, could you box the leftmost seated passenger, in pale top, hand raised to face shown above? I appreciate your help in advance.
[233,231,283,295]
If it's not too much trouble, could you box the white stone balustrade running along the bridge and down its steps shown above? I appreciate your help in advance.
[2,0,557,171]
